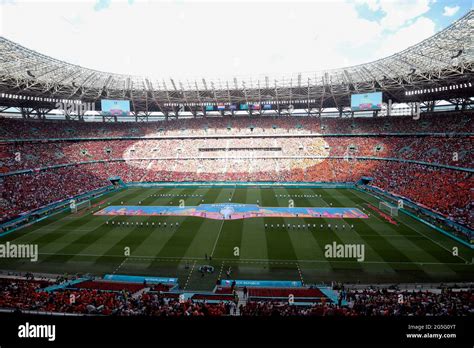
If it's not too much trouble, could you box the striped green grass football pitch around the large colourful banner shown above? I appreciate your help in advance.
[0,186,474,290]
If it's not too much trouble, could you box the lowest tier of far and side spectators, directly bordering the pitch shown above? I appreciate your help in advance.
[0,159,474,227]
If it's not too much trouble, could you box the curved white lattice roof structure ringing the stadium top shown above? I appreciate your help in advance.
[0,10,474,114]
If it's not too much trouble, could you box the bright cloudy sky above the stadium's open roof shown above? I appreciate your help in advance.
[0,0,472,81]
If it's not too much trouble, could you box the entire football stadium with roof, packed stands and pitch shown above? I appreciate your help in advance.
[0,1,474,343]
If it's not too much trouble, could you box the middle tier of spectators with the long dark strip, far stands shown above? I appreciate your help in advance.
[0,136,474,172]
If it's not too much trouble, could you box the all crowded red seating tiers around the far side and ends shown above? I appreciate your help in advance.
[0,111,474,228]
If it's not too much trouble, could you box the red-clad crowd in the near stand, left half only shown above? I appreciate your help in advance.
[0,278,231,317]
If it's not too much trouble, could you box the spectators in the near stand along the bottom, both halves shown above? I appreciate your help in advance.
[0,278,474,317]
